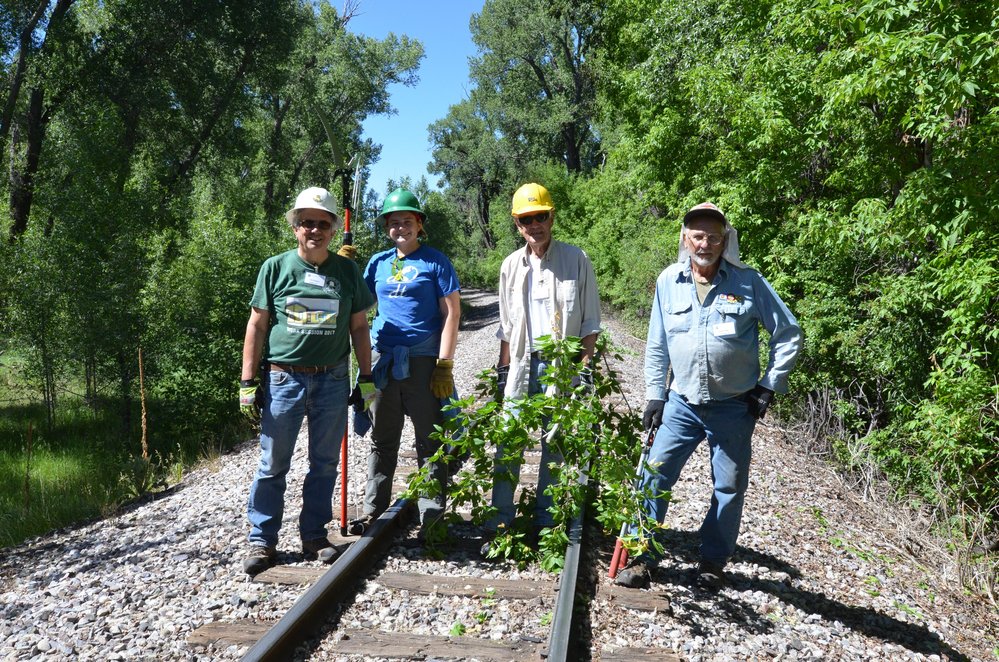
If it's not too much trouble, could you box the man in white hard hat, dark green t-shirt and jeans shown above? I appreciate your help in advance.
[240,187,375,575]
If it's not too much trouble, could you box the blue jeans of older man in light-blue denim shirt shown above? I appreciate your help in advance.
[642,392,756,565]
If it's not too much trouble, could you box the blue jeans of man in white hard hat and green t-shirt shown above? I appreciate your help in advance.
[247,361,350,547]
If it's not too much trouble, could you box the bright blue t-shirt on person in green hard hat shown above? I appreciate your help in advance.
[364,246,460,349]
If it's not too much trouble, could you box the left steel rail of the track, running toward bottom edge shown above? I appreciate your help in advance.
[242,499,409,662]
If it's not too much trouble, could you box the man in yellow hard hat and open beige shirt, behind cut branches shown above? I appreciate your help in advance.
[482,183,600,556]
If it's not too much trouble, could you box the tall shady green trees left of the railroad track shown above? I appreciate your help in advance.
[0,0,423,472]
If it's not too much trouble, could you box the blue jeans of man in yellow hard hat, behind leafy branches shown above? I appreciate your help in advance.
[488,358,563,528]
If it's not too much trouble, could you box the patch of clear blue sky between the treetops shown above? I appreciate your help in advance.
[348,0,482,196]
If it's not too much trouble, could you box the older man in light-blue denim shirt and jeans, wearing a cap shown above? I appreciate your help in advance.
[616,202,802,589]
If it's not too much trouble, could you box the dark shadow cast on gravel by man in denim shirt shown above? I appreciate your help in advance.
[655,529,970,661]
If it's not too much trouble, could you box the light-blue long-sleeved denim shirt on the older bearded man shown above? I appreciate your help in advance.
[645,257,803,405]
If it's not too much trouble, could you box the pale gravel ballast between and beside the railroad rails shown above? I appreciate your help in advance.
[0,292,999,661]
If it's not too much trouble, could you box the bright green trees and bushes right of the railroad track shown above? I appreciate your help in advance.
[432,0,999,588]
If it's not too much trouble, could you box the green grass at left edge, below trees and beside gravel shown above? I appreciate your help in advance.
[0,357,245,547]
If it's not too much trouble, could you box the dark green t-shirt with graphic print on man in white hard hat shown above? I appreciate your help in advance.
[250,250,375,366]
